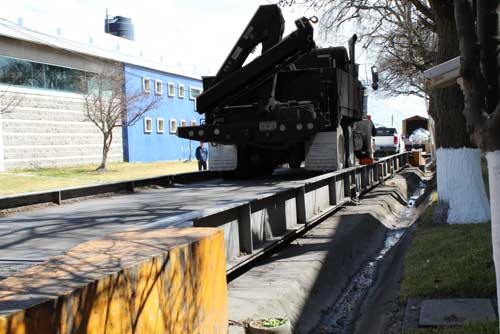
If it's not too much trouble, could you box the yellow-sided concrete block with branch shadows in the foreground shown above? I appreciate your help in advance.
[0,228,228,334]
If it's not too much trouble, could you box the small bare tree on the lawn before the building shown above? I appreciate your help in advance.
[82,69,160,171]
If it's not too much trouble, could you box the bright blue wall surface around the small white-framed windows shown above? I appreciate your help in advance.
[124,65,203,162]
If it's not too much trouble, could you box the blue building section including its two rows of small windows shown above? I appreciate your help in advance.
[123,64,202,162]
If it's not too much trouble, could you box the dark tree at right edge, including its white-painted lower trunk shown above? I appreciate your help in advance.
[455,0,500,316]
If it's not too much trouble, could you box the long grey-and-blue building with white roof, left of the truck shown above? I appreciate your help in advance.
[0,17,206,171]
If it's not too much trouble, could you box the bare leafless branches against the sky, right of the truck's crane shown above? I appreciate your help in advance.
[279,0,436,97]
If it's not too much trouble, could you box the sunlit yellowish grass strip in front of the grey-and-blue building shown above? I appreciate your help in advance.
[0,161,198,195]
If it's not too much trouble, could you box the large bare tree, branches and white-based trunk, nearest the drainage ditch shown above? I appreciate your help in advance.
[280,0,490,223]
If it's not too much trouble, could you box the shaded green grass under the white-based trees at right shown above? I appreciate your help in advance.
[401,193,498,334]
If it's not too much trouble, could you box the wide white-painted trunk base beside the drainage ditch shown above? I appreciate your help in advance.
[436,148,491,224]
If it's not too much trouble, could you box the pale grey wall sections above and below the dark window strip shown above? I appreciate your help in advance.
[0,37,123,170]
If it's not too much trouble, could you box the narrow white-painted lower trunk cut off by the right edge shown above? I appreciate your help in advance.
[486,151,500,316]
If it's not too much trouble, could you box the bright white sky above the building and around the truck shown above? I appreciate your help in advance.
[0,0,427,133]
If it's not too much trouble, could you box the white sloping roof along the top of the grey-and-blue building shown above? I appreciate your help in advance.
[0,18,201,80]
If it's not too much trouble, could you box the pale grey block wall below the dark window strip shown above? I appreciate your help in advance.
[0,86,123,169]
